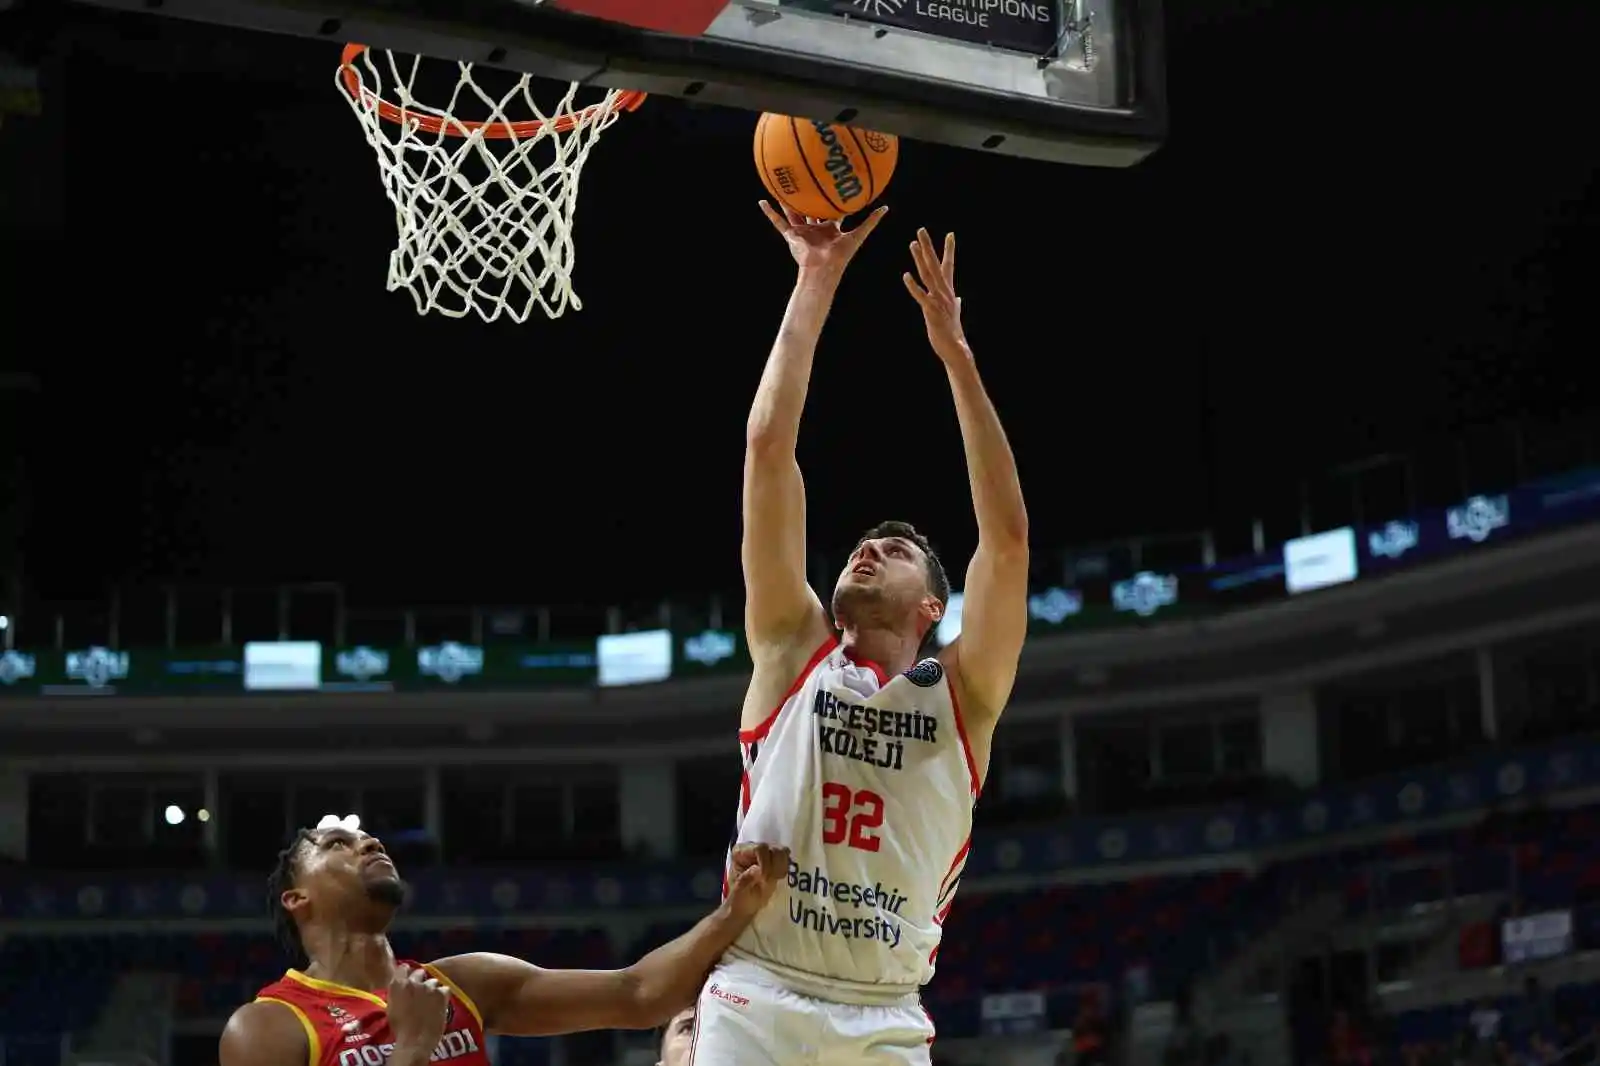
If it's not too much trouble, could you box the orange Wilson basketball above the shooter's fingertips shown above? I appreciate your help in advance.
[755,115,899,219]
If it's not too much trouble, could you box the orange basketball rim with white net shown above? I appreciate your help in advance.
[338,45,645,322]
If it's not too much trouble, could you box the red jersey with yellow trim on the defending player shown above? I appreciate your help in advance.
[256,962,490,1066]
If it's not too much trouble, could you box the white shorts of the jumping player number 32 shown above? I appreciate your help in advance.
[690,959,933,1066]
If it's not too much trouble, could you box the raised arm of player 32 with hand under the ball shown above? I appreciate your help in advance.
[739,200,885,663]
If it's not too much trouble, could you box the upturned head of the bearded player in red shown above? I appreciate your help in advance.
[267,823,405,957]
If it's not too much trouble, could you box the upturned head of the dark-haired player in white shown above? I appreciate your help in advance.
[834,522,950,645]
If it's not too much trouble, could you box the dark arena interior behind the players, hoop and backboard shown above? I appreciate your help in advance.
[0,0,1600,1066]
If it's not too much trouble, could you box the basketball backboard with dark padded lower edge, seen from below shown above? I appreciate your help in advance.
[68,0,1166,166]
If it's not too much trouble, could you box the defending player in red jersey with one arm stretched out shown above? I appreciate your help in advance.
[221,824,789,1066]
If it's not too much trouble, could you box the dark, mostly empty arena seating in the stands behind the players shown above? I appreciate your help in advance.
[9,808,1600,1066]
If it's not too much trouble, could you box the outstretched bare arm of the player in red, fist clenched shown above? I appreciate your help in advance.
[425,845,789,1030]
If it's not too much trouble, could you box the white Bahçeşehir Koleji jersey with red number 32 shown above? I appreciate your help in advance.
[730,640,979,1004]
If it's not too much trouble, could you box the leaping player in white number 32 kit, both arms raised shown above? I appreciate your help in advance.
[690,203,1029,1066]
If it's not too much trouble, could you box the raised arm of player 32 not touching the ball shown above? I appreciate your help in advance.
[904,229,1029,725]
